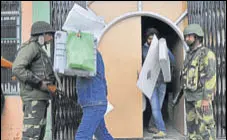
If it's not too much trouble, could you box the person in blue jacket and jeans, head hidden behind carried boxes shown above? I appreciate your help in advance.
[75,40,113,140]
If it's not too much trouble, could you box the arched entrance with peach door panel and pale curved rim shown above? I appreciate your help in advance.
[98,11,185,138]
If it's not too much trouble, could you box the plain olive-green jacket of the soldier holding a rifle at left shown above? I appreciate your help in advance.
[12,38,55,101]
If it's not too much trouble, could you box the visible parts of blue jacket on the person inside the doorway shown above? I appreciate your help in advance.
[142,42,175,86]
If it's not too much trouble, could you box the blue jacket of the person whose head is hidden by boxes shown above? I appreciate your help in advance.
[76,50,107,107]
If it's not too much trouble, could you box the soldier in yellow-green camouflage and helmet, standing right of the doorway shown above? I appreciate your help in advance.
[183,24,216,140]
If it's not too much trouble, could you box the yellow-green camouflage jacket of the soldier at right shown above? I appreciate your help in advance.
[182,46,216,101]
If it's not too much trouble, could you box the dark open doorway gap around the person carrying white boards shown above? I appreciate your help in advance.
[141,16,184,138]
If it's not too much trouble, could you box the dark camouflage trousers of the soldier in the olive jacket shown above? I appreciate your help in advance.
[22,100,49,140]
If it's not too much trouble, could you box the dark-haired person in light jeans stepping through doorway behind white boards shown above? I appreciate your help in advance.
[142,28,175,137]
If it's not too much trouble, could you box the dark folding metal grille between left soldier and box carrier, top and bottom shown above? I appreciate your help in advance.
[51,1,86,140]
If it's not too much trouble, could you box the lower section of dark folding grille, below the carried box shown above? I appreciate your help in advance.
[52,77,82,140]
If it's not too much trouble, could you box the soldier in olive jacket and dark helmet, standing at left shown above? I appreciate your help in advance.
[12,21,55,140]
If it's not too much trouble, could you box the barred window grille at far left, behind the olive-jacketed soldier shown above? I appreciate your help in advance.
[1,1,21,95]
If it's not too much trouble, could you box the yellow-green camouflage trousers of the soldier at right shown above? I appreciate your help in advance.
[186,100,216,140]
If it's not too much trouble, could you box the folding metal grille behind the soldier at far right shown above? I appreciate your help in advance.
[188,1,226,138]
